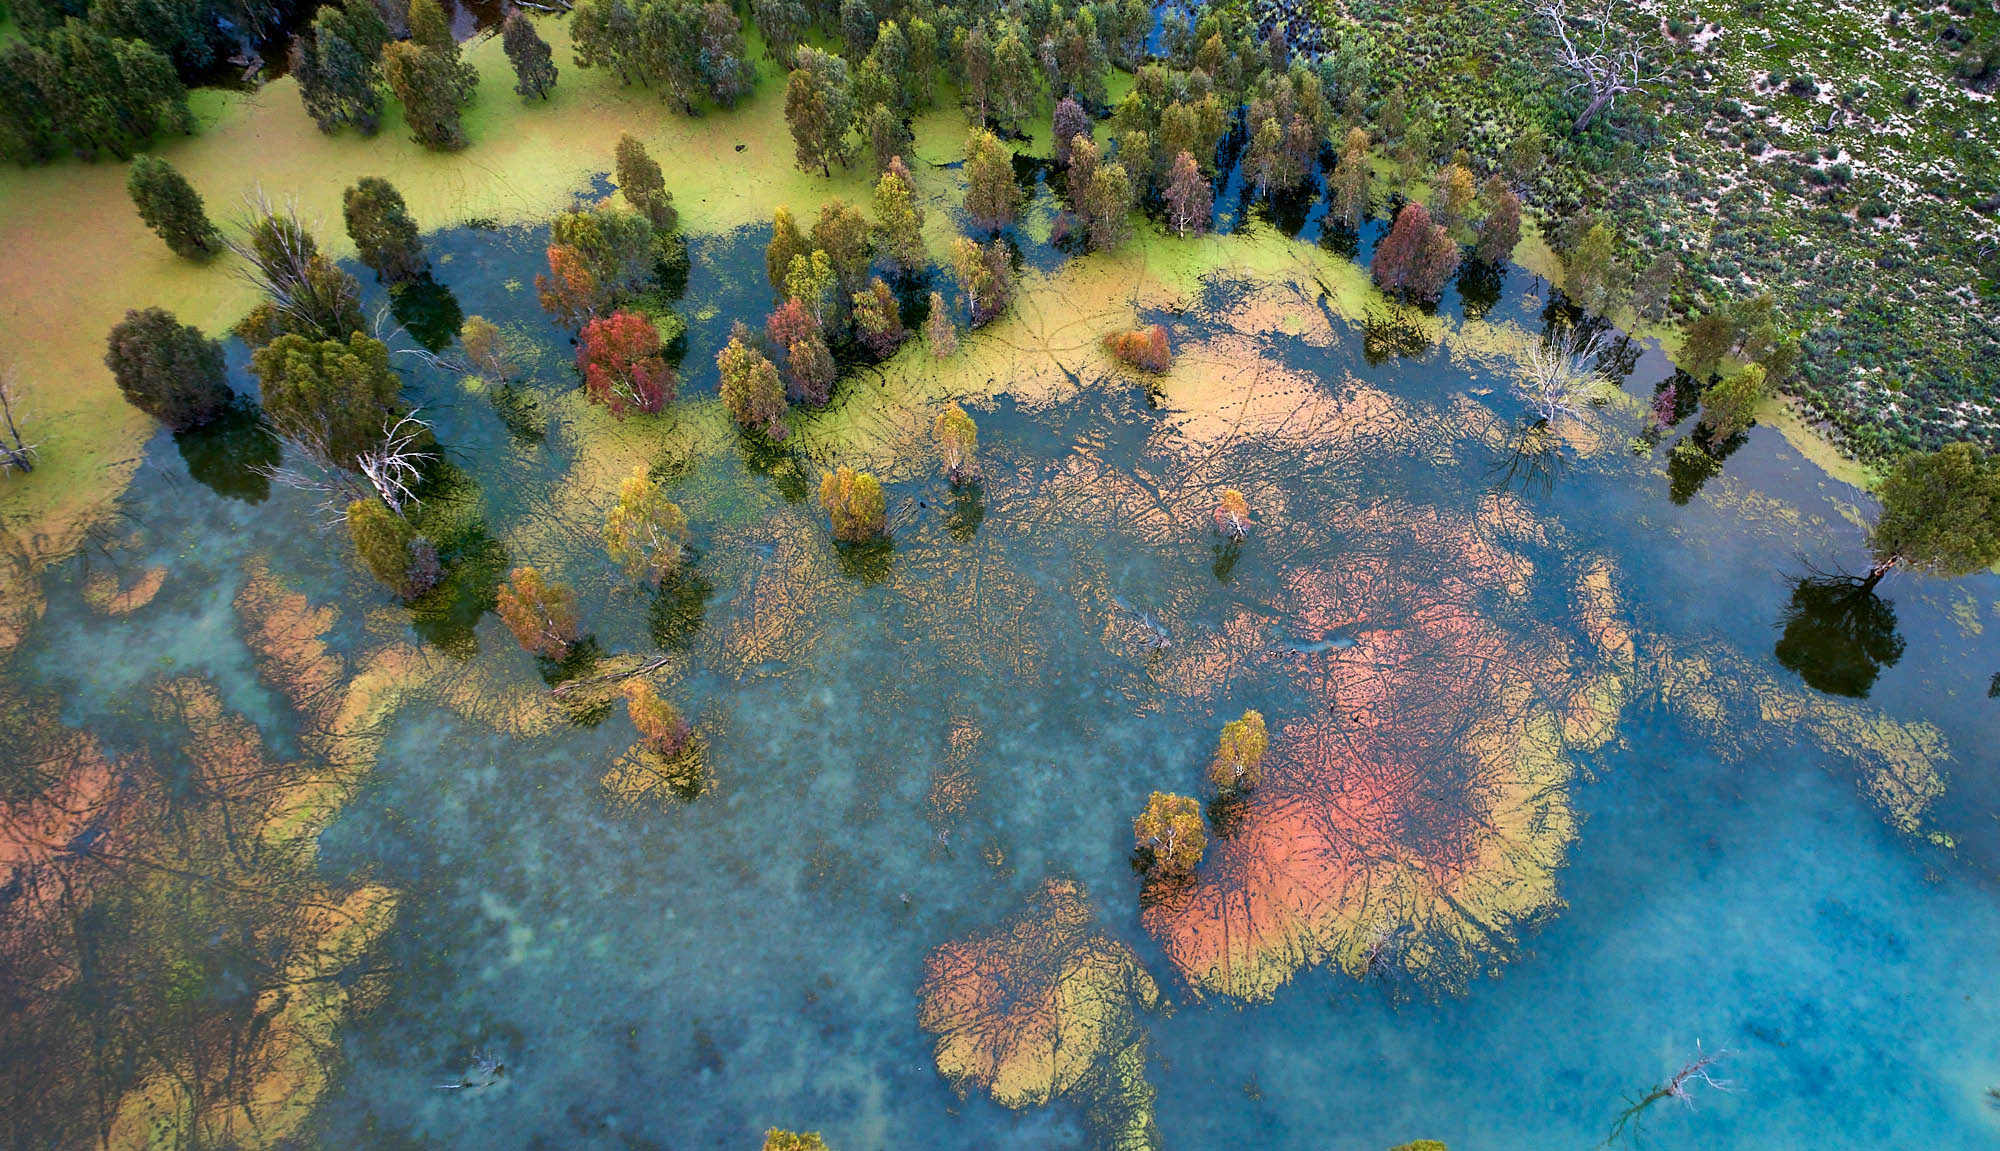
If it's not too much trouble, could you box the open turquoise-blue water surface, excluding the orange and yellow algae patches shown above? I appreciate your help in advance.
[0,206,2000,1151]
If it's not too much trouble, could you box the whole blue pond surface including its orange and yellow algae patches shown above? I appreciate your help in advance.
[4,208,2000,1149]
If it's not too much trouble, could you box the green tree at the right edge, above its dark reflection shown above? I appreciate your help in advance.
[1868,444,2000,587]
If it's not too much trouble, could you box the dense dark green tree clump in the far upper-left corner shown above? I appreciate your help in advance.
[0,18,194,164]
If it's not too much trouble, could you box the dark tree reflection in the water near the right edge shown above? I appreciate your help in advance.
[1776,576,1902,699]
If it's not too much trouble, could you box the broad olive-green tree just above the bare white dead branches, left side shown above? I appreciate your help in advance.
[250,332,402,468]
